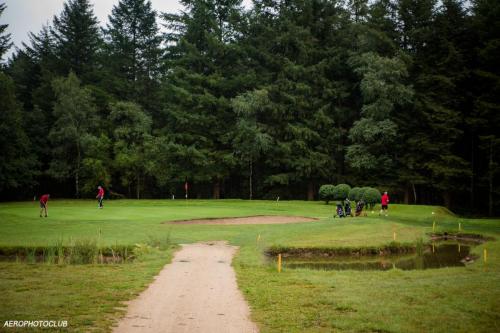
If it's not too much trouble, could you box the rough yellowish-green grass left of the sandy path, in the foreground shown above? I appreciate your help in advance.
[0,250,172,332]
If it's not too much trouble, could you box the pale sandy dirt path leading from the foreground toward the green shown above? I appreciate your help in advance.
[113,242,258,333]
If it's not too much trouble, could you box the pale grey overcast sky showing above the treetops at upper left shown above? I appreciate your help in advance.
[0,0,251,59]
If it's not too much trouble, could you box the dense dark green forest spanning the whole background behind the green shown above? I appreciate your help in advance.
[0,0,500,215]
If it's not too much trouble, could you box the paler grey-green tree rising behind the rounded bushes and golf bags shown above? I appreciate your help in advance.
[347,53,412,184]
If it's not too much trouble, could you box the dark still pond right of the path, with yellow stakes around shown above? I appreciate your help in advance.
[283,243,472,271]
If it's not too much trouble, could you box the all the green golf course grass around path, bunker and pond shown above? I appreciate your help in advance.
[0,200,500,332]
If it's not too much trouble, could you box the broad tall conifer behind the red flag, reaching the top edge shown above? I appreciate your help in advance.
[164,0,246,198]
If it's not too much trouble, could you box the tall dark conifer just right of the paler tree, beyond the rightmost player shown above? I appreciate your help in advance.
[399,0,470,207]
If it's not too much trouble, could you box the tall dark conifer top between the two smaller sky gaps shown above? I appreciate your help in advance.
[104,0,162,111]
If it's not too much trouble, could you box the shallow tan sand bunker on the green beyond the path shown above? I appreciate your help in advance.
[165,215,318,225]
